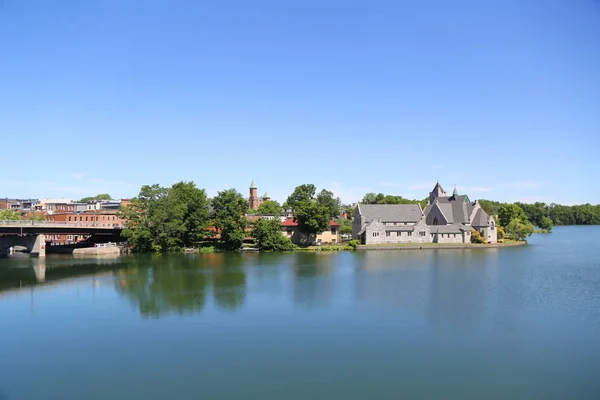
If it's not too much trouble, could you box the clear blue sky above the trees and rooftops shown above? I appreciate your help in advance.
[0,0,600,204]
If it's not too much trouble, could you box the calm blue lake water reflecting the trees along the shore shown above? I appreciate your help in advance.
[0,227,600,400]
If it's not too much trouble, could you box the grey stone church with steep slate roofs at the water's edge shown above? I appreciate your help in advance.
[352,183,497,244]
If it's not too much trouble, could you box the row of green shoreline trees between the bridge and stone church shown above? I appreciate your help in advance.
[119,182,341,252]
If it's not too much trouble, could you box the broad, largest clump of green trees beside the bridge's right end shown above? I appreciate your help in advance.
[119,182,210,252]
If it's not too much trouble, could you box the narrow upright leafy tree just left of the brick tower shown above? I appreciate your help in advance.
[212,189,248,250]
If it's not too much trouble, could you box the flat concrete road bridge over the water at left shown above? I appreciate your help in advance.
[0,220,124,257]
